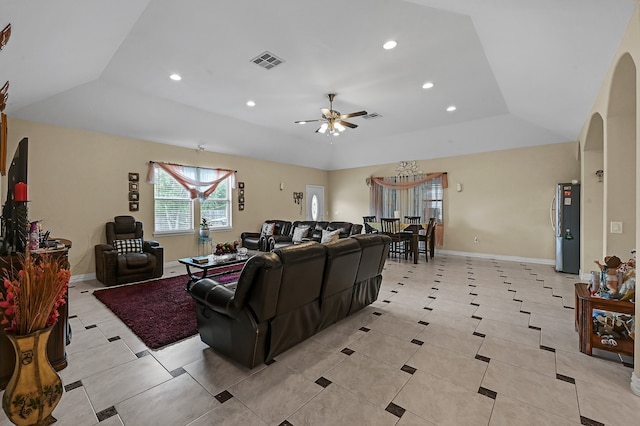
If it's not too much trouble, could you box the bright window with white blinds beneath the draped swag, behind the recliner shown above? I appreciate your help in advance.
[154,165,231,234]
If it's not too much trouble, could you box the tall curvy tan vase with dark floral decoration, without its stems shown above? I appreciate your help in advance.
[2,327,62,426]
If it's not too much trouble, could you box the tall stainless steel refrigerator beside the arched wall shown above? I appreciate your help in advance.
[552,183,580,274]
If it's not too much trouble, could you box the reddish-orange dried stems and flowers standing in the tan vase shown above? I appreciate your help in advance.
[0,251,71,336]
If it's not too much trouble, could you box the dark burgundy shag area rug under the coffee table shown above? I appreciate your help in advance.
[93,264,243,349]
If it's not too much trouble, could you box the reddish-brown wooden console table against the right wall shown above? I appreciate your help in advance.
[575,283,635,356]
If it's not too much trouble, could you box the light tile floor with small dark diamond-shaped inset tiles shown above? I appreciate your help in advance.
[0,255,640,426]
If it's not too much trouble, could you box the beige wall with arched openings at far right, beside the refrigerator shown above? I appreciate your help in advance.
[580,4,640,390]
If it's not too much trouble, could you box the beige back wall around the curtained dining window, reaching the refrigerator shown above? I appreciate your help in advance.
[329,142,580,262]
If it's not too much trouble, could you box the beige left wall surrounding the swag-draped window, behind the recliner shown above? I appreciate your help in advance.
[2,118,329,275]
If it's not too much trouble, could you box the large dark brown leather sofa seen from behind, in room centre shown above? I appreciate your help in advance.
[191,234,390,368]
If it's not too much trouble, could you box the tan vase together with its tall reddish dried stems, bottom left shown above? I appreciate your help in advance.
[0,248,71,425]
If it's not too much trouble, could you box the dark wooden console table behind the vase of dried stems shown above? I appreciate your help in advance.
[0,240,71,389]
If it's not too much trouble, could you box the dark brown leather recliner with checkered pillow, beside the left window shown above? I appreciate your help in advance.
[95,216,164,285]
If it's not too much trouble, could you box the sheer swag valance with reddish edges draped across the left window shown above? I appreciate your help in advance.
[147,161,236,200]
